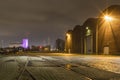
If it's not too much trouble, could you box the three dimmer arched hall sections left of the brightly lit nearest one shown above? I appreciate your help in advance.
[66,18,97,54]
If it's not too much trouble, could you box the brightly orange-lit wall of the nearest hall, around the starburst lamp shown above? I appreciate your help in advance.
[99,5,120,54]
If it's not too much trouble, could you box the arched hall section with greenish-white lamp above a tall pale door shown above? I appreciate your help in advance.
[83,18,98,54]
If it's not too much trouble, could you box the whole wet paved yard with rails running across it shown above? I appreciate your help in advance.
[0,53,120,80]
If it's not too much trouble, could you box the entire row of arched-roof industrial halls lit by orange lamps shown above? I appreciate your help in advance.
[65,5,120,54]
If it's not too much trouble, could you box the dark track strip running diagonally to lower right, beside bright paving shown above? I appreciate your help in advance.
[40,57,120,80]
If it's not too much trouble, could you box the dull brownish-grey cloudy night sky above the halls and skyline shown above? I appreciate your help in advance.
[0,0,120,46]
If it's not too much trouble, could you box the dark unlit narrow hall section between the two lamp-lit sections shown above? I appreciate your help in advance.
[72,25,83,53]
